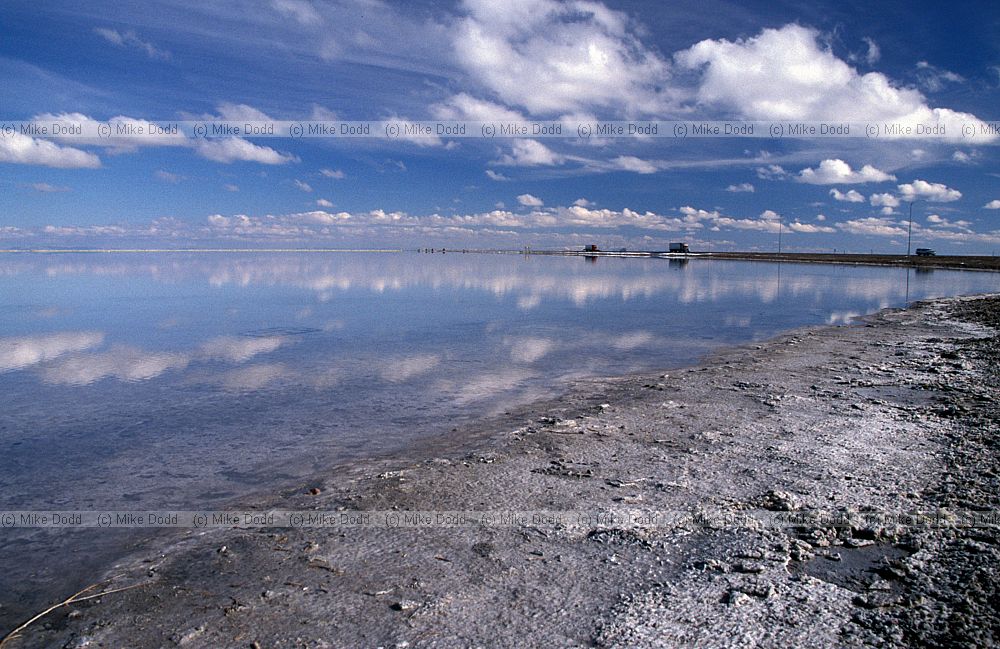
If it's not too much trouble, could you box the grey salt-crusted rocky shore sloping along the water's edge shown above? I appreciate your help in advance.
[5,297,1000,649]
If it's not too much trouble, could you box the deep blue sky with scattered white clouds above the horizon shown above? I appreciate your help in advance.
[0,0,1000,254]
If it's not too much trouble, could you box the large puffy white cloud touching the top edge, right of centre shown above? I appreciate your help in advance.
[453,0,669,114]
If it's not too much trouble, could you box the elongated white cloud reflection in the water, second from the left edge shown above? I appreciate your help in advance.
[41,345,191,385]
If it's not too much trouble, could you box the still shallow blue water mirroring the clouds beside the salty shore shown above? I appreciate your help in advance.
[0,253,1000,628]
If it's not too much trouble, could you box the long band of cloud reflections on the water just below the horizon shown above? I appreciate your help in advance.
[0,253,984,310]
